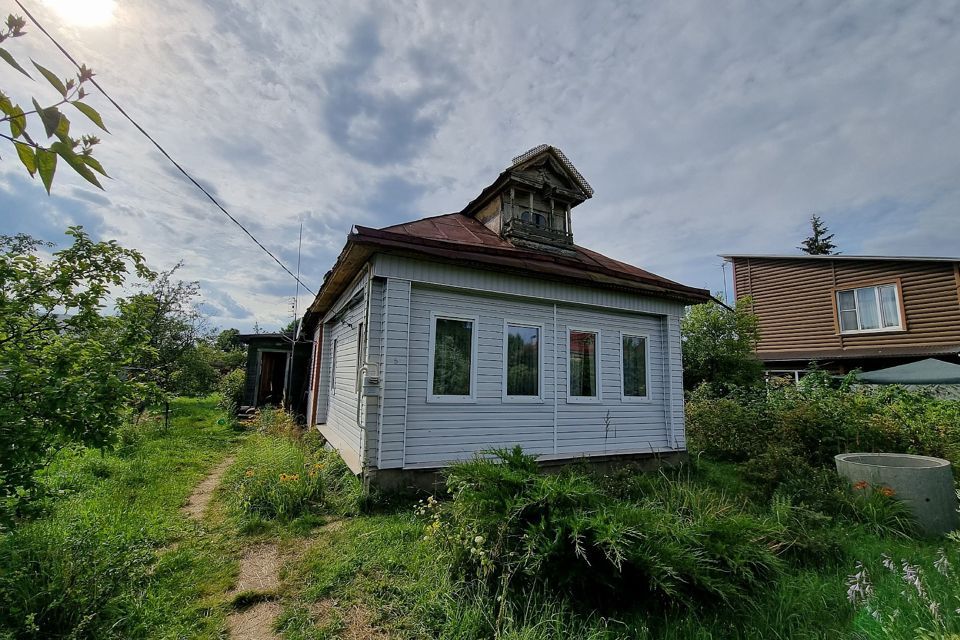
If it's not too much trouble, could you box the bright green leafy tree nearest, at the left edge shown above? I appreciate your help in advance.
[0,227,153,521]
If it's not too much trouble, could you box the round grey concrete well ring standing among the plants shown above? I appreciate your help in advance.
[835,453,958,536]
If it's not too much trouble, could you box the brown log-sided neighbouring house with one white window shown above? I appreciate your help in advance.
[722,255,960,373]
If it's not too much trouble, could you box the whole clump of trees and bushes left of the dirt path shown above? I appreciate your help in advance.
[0,227,244,531]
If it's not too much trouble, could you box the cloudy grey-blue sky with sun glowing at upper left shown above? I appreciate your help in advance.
[0,0,960,329]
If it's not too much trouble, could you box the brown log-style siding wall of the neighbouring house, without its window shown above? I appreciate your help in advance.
[734,258,960,356]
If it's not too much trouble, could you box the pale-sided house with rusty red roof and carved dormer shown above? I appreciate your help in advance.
[304,147,709,478]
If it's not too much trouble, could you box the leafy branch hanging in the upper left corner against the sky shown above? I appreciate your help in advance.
[0,14,109,193]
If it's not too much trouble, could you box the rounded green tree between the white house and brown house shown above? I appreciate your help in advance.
[680,297,763,393]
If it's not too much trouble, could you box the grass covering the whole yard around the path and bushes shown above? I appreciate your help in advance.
[0,399,960,640]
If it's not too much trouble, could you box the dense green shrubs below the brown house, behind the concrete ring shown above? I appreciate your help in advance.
[687,373,960,496]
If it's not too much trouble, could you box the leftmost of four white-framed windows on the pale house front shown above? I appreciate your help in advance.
[427,315,477,402]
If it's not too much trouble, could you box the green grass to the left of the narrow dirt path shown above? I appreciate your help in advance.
[0,398,243,638]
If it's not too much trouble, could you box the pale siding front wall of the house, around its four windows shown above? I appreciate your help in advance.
[377,274,685,468]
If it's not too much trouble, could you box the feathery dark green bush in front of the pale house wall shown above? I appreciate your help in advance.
[421,448,781,608]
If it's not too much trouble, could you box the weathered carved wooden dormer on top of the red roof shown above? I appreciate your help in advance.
[462,144,593,253]
